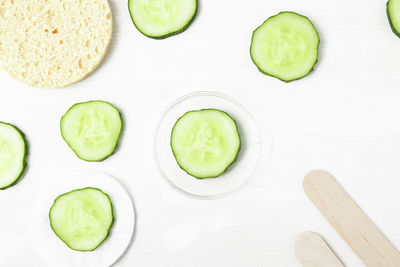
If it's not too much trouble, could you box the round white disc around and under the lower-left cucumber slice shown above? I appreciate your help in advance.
[28,171,135,267]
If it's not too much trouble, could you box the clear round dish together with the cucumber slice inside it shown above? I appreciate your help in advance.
[154,91,272,199]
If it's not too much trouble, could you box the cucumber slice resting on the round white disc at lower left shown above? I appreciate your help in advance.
[49,187,114,251]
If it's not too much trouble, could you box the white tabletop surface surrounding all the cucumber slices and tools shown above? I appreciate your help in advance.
[0,0,400,267]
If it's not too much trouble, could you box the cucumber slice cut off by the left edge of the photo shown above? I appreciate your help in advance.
[0,122,28,189]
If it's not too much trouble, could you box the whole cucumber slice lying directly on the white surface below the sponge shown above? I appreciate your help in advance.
[61,101,122,161]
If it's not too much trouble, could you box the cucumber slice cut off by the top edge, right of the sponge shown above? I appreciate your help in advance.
[128,0,197,39]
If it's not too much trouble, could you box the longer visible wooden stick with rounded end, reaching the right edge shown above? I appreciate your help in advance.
[303,170,400,267]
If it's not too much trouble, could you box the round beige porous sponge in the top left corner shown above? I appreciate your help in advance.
[0,0,112,88]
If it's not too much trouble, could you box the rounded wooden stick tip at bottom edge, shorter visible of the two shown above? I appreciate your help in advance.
[294,232,344,267]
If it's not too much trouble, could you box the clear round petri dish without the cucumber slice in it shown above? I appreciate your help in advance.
[154,92,268,199]
